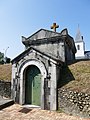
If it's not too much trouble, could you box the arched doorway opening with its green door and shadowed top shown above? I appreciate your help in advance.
[25,65,41,106]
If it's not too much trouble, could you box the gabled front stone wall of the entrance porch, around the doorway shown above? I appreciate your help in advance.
[11,50,59,110]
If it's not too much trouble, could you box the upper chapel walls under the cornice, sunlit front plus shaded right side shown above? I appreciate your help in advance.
[27,38,75,62]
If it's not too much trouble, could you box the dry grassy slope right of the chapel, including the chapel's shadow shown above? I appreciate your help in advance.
[59,60,90,94]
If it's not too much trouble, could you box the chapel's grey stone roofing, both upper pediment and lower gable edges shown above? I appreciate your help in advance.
[12,29,76,62]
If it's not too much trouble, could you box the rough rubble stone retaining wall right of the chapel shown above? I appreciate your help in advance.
[58,88,90,118]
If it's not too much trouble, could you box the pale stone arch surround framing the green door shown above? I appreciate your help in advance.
[19,59,47,108]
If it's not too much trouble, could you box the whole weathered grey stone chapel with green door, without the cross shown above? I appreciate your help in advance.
[11,29,76,110]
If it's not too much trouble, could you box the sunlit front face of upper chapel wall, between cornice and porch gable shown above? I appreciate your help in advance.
[29,41,65,62]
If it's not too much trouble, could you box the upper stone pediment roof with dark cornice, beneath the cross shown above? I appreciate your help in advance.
[22,28,76,53]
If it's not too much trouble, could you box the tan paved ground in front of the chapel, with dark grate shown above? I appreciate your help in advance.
[0,104,90,120]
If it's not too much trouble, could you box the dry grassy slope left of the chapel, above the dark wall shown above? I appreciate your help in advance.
[0,64,11,81]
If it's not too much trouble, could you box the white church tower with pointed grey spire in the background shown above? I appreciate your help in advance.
[75,27,85,59]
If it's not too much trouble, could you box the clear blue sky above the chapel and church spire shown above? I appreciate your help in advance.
[0,0,90,59]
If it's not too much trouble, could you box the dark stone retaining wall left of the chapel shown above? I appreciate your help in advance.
[0,80,11,98]
